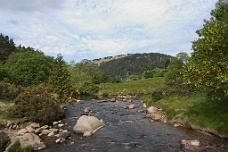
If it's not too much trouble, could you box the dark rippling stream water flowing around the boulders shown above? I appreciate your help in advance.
[40,100,228,152]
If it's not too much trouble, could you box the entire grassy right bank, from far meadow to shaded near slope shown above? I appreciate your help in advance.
[100,78,228,137]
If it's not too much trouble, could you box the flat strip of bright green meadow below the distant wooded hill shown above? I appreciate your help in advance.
[99,77,165,95]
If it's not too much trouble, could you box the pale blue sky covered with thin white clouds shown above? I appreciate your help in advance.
[0,0,217,62]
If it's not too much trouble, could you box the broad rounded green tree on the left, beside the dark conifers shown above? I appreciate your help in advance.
[6,50,53,86]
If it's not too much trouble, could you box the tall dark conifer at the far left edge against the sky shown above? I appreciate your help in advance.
[0,34,16,63]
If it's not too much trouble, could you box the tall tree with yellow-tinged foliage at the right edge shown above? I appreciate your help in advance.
[186,0,228,99]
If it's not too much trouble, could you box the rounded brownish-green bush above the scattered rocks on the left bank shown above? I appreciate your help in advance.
[7,86,64,124]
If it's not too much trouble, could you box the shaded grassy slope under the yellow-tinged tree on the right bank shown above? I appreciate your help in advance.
[144,94,228,136]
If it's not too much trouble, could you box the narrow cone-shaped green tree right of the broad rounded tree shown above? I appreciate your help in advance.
[49,54,72,101]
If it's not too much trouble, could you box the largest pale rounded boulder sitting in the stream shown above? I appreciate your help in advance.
[73,115,104,134]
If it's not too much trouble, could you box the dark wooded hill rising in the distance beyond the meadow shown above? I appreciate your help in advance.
[99,53,174,77]
